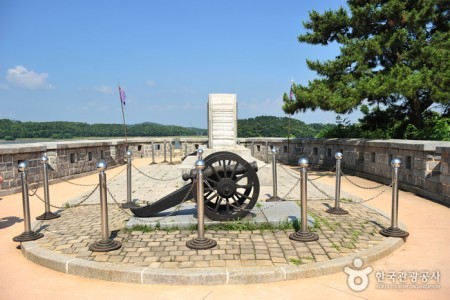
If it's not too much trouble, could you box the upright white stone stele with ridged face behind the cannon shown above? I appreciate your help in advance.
[208,94,237,150]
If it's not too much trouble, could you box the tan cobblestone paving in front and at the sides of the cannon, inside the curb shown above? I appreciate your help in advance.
[36,200,390,268]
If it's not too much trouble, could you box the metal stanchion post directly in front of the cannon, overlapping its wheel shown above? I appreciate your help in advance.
[186,161,217,250]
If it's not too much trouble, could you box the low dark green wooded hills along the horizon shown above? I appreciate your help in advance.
[0,116,329,140]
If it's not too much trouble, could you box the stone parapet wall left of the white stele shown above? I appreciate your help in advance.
[0,138,207,195]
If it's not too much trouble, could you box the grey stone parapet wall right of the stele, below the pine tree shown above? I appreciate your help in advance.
[243,138,450,204]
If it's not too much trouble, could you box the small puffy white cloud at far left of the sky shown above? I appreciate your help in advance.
[6,66,54,90]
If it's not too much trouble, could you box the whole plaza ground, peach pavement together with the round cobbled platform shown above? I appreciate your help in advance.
[0,143,450,299]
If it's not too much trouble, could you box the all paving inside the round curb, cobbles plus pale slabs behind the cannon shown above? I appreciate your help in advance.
[29,164,390,268]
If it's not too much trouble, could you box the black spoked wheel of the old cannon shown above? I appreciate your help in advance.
[204,151,259,221]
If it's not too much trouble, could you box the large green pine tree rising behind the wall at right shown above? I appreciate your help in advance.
[283,0,450,138]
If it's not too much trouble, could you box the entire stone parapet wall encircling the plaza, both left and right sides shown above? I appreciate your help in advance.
[0,137,450,204]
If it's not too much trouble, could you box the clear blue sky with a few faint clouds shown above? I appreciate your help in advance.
[0,0,361,128]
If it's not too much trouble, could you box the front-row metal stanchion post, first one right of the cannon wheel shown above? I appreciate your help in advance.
[289,158,319,242]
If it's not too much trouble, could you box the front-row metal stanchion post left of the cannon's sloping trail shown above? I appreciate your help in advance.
[89,161,122,252]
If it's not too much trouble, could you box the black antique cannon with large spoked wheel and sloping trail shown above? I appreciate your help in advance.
[131,151,259,221]
